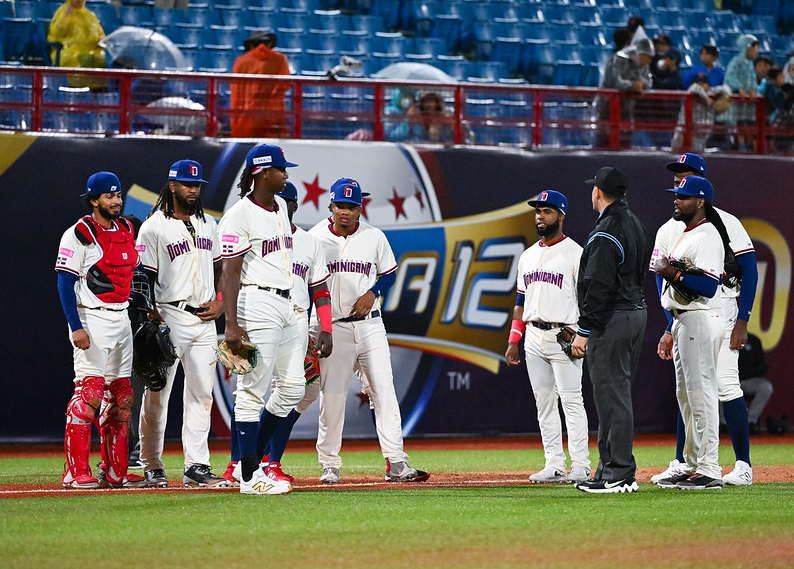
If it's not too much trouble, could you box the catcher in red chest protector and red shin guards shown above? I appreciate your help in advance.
[55,172,145,488]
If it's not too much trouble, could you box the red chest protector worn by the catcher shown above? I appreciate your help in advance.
[74,215,138,303]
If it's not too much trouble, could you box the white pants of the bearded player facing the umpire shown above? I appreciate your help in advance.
[524,323,590,471]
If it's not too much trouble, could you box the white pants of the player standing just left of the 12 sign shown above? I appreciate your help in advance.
[317,318,408,468]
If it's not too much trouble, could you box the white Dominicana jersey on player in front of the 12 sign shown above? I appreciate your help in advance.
[309,219,397,320]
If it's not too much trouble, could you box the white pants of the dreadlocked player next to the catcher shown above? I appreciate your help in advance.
[140,304,218,470]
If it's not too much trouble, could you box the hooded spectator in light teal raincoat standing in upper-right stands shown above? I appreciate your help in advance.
[725,34,758,151]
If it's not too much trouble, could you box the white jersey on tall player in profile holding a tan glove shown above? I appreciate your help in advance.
[218,194,294,290]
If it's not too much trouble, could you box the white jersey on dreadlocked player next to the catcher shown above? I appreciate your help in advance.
[136,210,221,306]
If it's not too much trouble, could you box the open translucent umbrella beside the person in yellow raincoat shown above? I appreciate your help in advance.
[99,26,190,70]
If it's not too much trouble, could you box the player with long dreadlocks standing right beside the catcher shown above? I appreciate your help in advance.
[137,160,228,487]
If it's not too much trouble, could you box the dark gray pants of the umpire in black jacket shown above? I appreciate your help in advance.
[587,309,648,481]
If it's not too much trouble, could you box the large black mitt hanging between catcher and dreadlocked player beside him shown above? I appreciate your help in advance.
[132,320,176,391]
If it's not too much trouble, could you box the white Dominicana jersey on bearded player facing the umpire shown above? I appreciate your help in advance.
[516,236,582,324]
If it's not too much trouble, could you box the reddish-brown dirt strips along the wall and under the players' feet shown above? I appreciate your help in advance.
[0,433,794,498]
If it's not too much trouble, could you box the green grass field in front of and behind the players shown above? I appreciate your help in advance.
[0,445,794,569]
